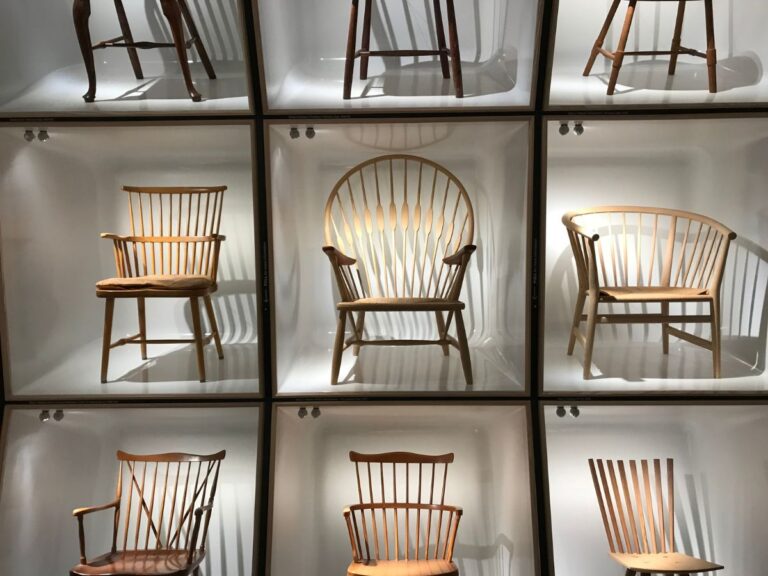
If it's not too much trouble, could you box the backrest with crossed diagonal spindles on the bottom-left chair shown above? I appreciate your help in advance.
[112,450,226,551]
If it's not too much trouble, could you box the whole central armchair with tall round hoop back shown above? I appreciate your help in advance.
[323,154,475,386]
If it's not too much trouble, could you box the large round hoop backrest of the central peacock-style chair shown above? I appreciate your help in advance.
[325,154,474,298]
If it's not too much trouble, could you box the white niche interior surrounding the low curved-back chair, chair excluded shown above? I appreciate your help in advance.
[542,118,768,393]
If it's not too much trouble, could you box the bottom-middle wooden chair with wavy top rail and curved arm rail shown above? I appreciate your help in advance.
[344,452,463,576]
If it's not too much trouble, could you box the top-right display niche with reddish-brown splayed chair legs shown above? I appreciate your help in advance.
[549,0,768,108]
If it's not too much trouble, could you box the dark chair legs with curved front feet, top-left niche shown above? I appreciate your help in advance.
[72,0,216,102]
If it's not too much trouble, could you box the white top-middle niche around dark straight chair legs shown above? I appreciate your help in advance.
[257,0,539,111]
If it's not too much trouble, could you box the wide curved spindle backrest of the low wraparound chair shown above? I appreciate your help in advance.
[563,206,736,291]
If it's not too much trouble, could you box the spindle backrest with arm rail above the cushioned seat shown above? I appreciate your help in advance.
[110,186,227,282]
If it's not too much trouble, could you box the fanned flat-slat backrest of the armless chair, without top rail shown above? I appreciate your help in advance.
[589,458,675,554]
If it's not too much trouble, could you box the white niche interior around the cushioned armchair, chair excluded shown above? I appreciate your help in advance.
[0,123,259,399]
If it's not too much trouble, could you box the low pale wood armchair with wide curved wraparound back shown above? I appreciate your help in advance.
[562,206,736,379]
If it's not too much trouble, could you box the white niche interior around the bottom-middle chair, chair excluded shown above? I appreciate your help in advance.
[268,403,537,576]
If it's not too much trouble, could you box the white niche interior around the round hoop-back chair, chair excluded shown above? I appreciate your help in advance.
[268,120,530,395]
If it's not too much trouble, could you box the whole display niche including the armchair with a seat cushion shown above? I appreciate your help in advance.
[0,124,259,398]
